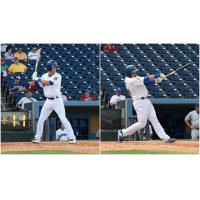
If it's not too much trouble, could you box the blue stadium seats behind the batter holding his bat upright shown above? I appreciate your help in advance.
[3,44,99,100]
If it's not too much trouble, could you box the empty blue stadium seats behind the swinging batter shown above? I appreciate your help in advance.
[101,44,199,98]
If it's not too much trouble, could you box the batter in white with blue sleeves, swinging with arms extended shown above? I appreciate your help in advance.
[118,65,175,143]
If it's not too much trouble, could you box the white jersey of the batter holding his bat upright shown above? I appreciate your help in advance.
[41,72,62,98]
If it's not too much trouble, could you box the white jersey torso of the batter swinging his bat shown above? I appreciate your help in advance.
[125,76,148,100]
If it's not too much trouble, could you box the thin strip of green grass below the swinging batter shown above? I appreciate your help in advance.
[102,150,195,154]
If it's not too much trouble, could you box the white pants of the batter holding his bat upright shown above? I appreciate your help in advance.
[35,97,75,140]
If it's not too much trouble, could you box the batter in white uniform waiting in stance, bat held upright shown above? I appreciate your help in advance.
[32,60,76,144]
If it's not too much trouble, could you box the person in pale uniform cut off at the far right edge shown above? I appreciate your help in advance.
[185,104,199,140]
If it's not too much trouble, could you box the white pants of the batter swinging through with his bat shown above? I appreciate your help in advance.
[122,99,170,141]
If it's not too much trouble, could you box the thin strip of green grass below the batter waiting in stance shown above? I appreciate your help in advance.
[1,150,82,154]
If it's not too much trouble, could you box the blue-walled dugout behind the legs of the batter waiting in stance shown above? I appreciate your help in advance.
[32,101,99,141]
